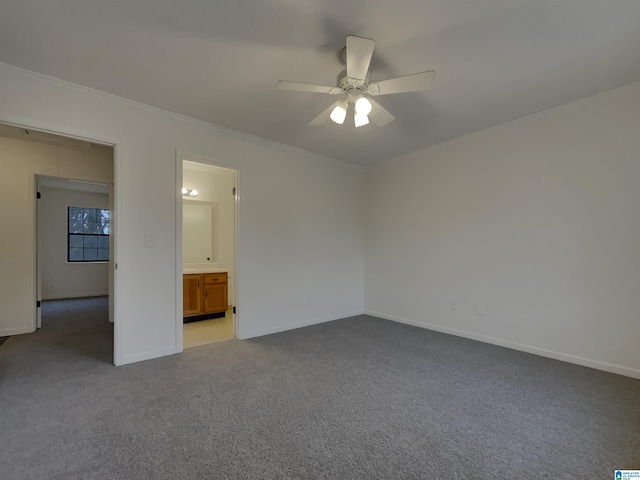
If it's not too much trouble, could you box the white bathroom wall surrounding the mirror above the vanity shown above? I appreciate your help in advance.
[182,162,236,305]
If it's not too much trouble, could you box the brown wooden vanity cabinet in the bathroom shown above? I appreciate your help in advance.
[182,272,228,317]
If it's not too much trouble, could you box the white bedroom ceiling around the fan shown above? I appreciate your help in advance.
[0,0,640,165]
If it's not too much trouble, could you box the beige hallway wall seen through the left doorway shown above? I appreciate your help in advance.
[0,135,113,336]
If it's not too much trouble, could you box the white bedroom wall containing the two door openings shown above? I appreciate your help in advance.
[0,64,364,364]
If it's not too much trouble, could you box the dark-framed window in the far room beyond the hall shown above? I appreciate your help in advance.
[67,207,110,262]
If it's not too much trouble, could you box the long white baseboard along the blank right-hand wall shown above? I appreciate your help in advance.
[364,310,640,379]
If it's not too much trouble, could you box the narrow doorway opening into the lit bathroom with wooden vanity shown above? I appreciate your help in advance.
[176,157,238,348]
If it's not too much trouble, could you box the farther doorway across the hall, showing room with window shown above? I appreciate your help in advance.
[36,176,113,362]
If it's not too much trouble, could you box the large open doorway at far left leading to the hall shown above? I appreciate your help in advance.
[0,124,117,363]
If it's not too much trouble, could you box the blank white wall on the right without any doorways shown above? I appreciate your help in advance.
[365,85,640,377]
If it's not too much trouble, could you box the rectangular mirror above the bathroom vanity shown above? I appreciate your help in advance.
[182,200,218,263]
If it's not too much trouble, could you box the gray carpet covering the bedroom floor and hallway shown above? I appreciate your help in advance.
[0,299,640,480]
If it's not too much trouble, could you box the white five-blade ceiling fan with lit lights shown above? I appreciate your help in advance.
[277,35,436,127]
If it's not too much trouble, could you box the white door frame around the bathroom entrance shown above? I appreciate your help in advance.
[175,149,241,353]
